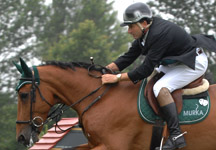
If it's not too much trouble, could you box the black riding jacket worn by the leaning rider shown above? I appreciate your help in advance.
[114,17,215,83]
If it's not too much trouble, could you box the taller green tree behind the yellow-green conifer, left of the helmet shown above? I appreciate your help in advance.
[72,0,131,60]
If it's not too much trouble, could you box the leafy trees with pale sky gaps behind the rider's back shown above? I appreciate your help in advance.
[148,0,216,82]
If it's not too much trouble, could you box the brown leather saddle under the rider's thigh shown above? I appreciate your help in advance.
[144,72,208,116]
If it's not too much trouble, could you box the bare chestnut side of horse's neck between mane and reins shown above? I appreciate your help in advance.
[40,66,101,105]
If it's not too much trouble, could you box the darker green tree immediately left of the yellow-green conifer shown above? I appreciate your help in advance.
[35,0,80,59]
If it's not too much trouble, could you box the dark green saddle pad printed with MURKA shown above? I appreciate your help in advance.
[137,79,210,124]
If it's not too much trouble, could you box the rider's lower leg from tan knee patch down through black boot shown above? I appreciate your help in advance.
[156,88,186,150]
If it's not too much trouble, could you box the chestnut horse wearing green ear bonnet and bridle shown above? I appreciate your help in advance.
[16,59,216,150]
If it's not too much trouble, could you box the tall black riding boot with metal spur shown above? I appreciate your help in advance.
[155,103,186,150]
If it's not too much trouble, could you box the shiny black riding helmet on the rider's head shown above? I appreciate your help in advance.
[120,2,152,27]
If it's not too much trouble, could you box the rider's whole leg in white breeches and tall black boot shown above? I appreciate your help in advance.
[153,49,208,150]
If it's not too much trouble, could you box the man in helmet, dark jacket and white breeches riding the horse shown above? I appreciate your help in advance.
[102,2,208,150]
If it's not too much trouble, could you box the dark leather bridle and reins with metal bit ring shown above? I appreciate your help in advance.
[16,64,113,132]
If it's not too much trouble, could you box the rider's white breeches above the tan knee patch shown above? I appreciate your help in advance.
[153,49,208,97]
